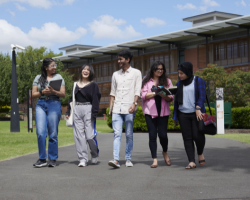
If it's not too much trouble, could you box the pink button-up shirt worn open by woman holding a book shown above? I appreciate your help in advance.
[141,78,174,118]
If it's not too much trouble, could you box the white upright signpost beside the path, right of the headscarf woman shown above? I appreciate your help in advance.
[216,88,225,134]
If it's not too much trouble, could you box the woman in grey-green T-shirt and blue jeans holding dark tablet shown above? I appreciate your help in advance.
[32,58,65,167]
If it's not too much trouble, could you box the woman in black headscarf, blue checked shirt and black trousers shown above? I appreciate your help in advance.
[173,62,206,169]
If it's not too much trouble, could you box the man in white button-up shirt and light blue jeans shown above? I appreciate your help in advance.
[108,50,142,168]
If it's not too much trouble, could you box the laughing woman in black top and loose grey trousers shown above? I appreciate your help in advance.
[66,64,101,167]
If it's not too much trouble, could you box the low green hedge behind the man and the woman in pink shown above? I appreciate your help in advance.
[106,106,215,132]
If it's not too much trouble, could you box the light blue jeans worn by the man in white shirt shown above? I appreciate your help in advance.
[112,112,135,161]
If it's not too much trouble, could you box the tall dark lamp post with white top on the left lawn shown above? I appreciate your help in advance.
[10,44,25,132]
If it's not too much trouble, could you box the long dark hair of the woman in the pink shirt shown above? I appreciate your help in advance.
[142,61,168,88]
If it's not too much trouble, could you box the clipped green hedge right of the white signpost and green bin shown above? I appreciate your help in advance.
[231,107,250,129]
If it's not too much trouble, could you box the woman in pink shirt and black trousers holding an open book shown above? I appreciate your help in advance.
[141,61,173,168]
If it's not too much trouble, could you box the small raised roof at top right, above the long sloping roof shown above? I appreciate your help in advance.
[183,11,242,22]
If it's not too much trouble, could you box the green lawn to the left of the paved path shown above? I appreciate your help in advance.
[0,120,112,160]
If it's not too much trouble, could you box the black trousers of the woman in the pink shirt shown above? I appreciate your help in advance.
[145,115,168,158]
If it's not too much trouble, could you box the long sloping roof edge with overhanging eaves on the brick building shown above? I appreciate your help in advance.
[54,15,250,62]
